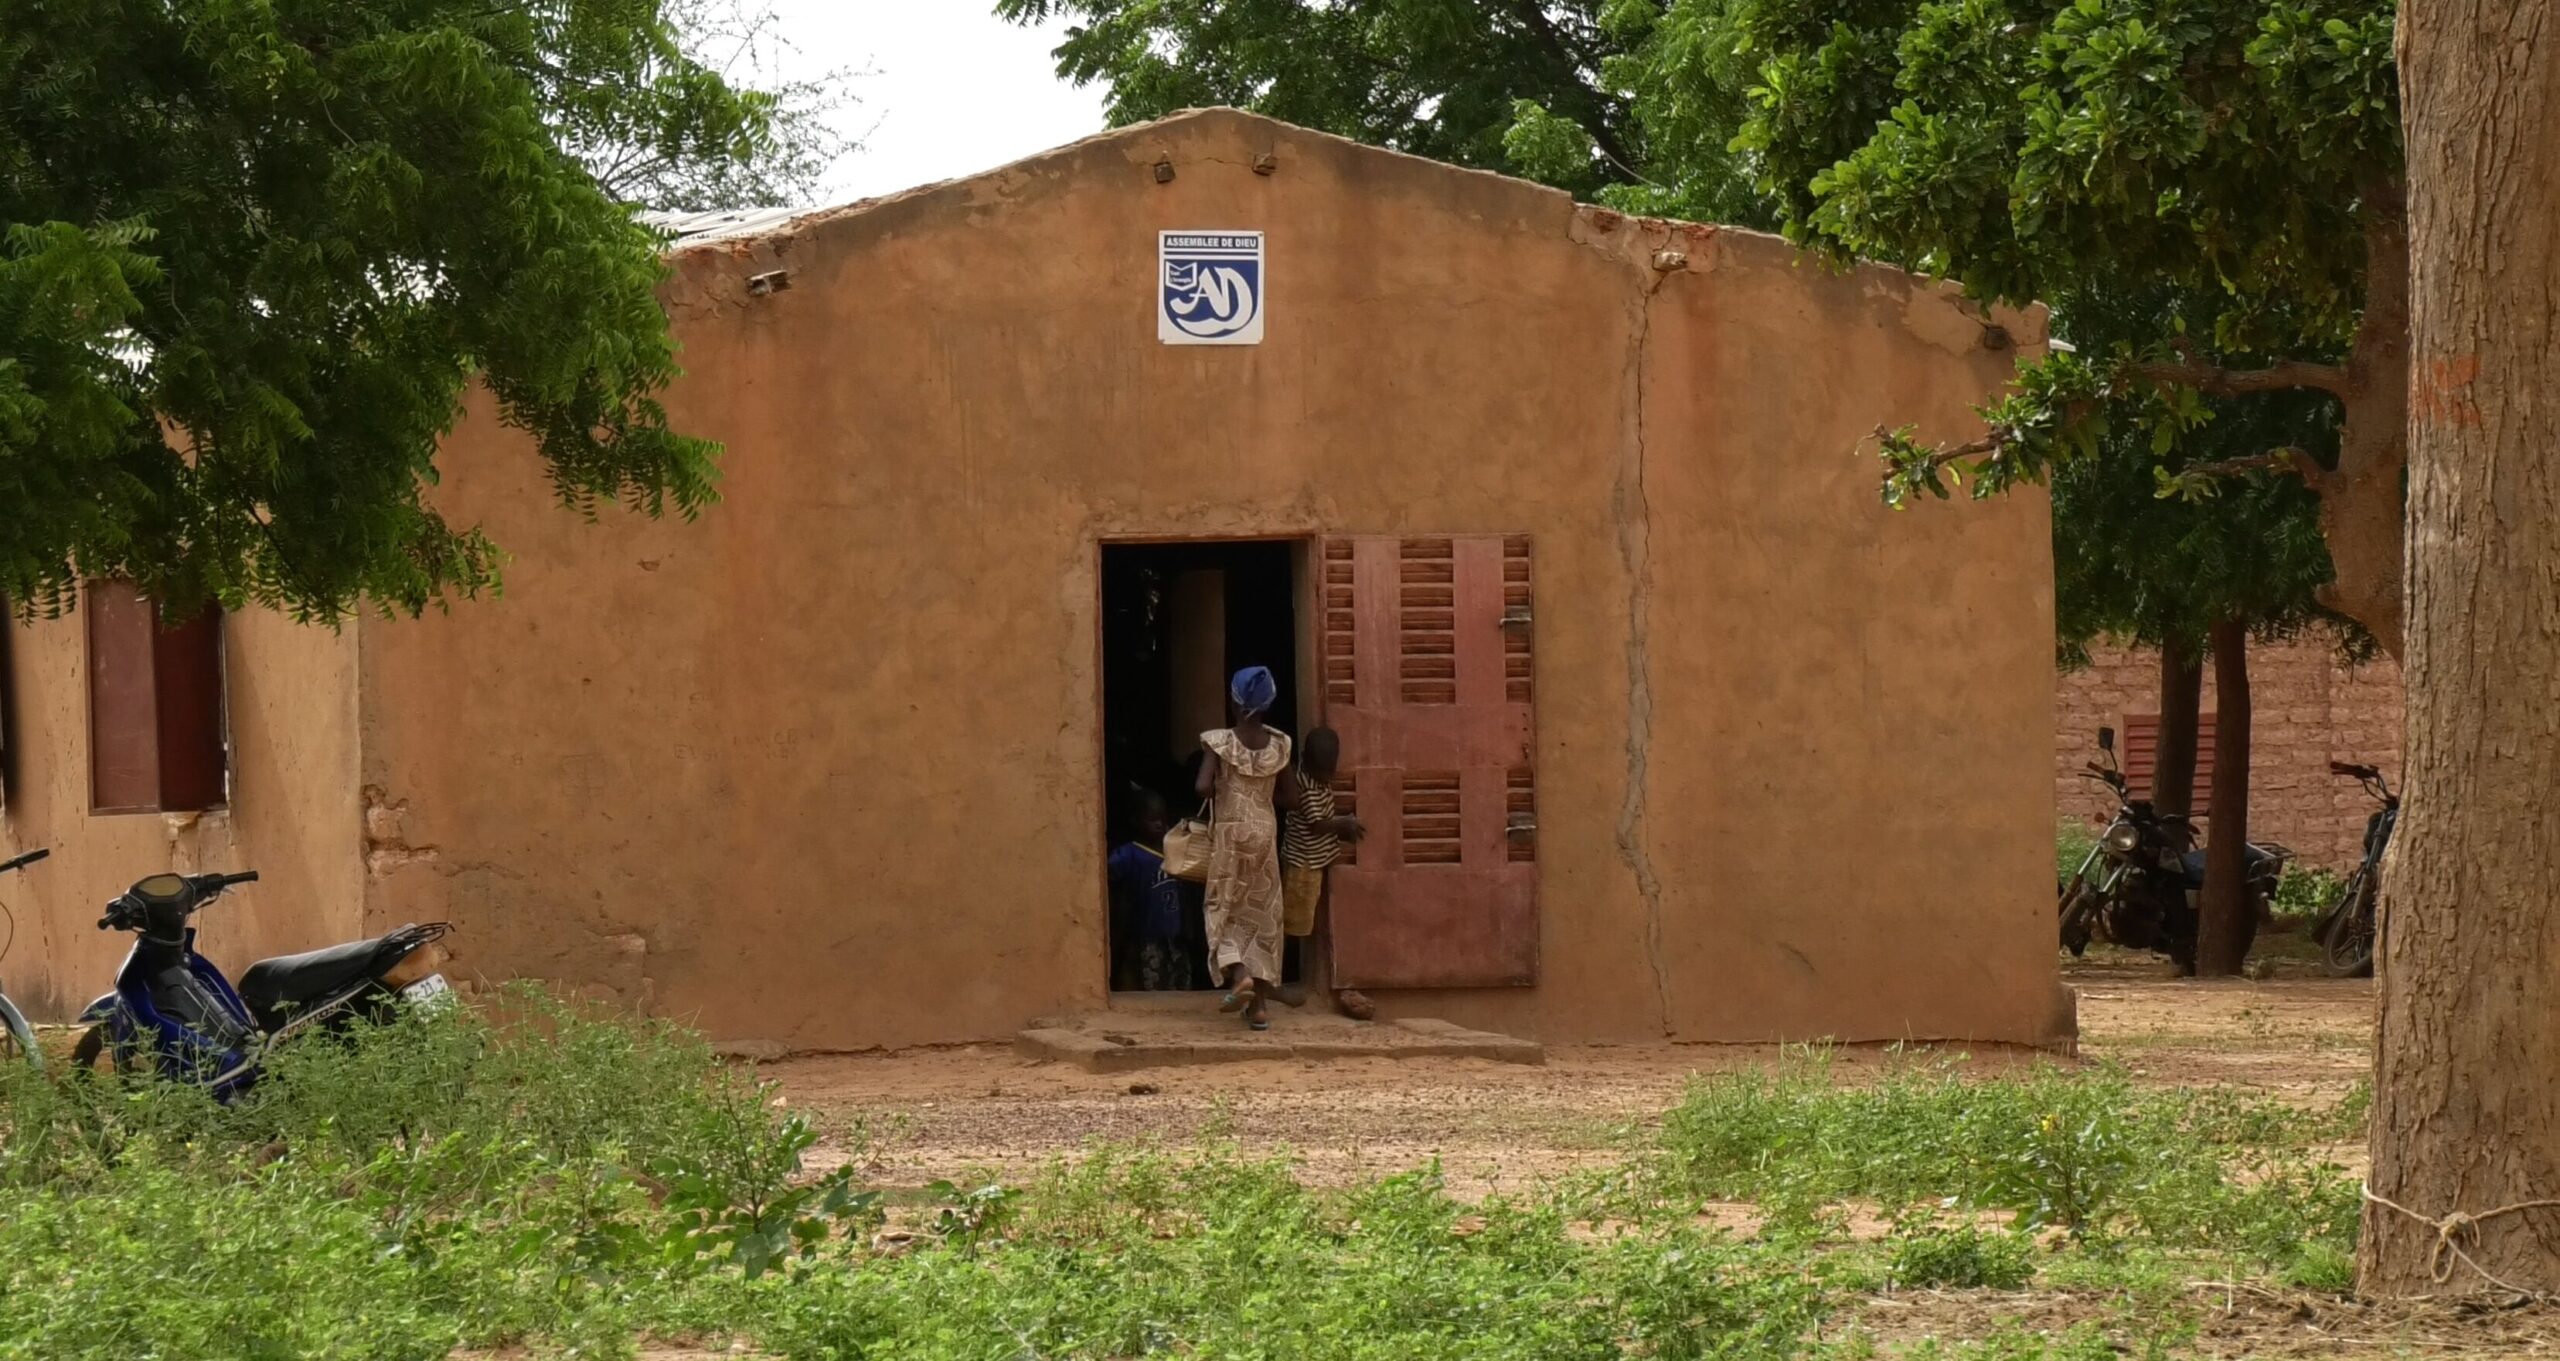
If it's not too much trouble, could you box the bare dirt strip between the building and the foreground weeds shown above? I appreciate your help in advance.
[765,957,2373,1195]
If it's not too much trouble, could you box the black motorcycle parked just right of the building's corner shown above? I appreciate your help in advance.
[2056,727,2294,975]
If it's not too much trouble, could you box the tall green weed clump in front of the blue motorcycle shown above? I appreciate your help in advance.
[0,990,863,1361]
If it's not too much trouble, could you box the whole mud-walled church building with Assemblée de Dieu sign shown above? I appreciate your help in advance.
[0,110,2068,1049]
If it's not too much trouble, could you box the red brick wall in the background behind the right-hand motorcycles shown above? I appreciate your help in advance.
[2053,637,2401,867]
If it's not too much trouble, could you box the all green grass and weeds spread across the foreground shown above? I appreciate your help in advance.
[0,993,2363,1361]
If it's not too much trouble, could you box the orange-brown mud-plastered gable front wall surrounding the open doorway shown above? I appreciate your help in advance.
[361,113,2058,1049]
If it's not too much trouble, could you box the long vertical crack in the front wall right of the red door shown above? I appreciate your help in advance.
[1610,266,1672,1036]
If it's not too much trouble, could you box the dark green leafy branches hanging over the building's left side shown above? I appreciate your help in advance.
[0,0,844,619]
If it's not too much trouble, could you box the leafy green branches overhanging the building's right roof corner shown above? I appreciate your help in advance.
[1679,0,2406,645]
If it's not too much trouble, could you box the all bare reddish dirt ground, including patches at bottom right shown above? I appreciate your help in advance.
[742,954,2560,1358]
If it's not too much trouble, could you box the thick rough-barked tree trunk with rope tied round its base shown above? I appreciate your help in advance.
[2358,0,2560,1294]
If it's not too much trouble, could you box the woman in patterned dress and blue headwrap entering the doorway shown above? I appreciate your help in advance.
[1198,665,1298,1031]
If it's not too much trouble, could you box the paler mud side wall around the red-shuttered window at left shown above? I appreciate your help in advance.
[0,611,364,1021]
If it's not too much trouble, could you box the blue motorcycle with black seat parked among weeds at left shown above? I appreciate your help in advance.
[72,870,451,1100]
